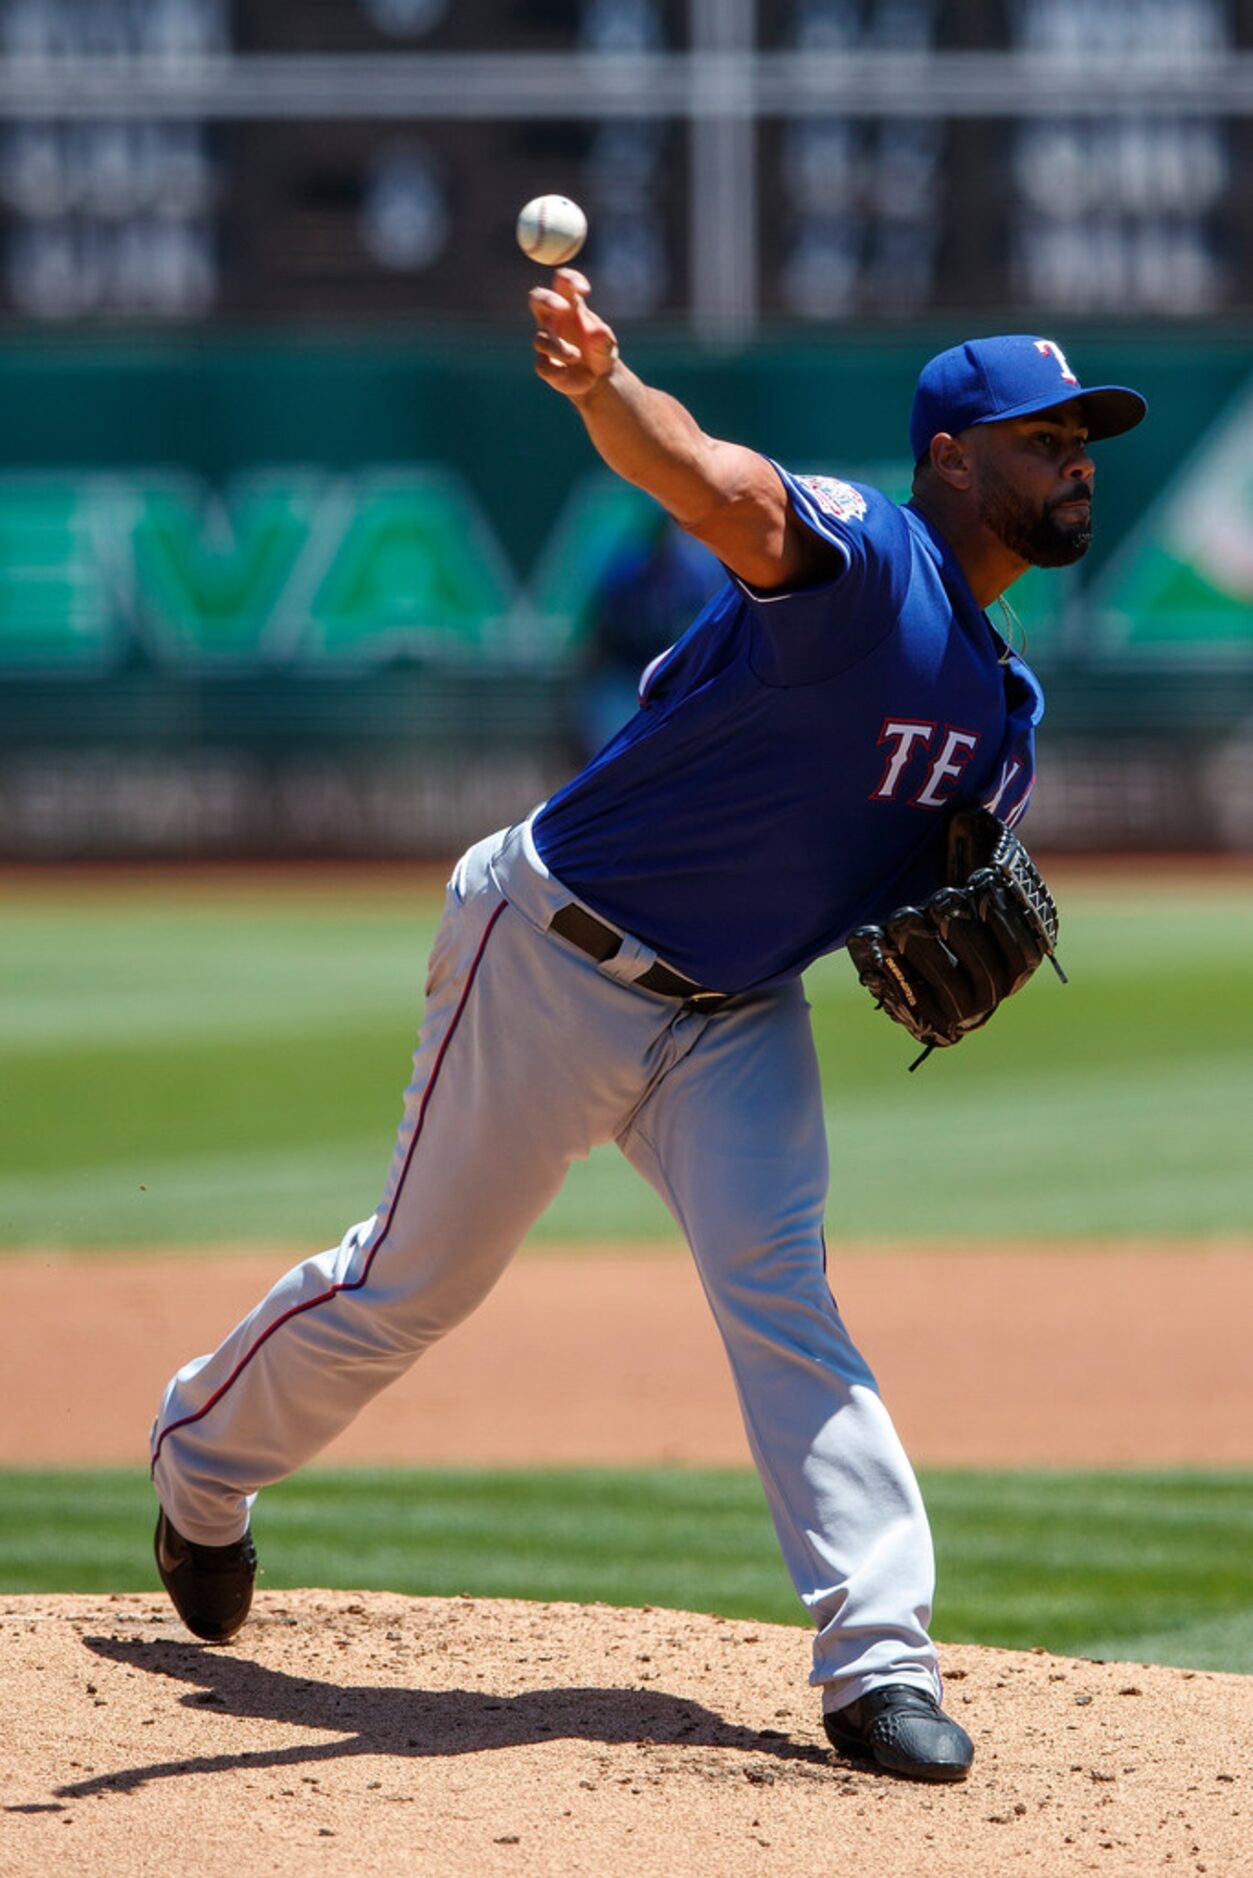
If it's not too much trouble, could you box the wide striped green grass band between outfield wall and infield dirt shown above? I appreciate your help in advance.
[0,873,1253,1249]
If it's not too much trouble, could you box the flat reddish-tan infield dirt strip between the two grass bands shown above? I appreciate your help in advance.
[0,1241,1253,1467]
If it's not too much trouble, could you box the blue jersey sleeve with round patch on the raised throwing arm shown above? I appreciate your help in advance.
[731,458,911,685]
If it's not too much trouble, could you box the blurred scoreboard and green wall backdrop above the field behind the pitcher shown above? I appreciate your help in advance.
[0,0,1253,862]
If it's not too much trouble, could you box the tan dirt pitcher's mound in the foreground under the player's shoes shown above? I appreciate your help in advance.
[0,1591,1253,1878]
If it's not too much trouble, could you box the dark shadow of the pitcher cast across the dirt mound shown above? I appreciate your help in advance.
[56,1636,830,1799]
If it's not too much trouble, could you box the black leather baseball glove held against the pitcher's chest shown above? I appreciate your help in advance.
[847,808,1065,1069]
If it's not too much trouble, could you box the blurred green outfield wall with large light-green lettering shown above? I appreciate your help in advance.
[0,323,1253,854]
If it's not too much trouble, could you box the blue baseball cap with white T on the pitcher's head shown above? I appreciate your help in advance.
[909,332,1148,462]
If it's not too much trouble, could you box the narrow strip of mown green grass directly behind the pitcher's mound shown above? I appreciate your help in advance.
[0,1469,1253,1671]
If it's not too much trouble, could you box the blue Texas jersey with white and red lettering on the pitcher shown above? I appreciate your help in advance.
[534,470,1043,992]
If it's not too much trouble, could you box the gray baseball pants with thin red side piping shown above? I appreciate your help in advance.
[152,823,941,1709]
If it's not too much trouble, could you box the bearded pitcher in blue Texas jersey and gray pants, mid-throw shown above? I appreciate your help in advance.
[152,269,1146,1780]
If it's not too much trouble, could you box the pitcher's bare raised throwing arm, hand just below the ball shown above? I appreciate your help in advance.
[530,267,843,588]
